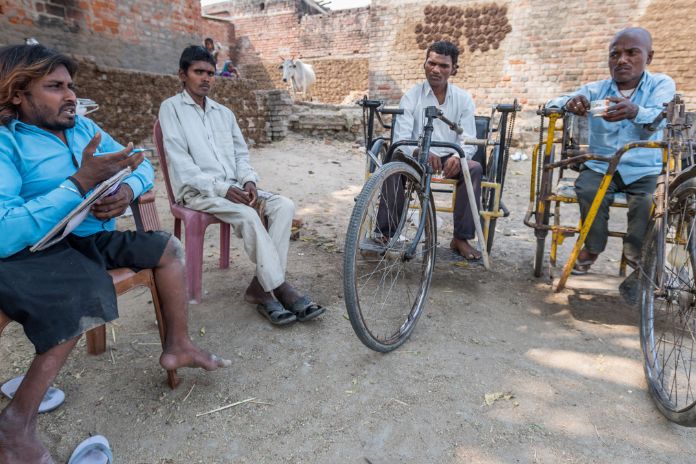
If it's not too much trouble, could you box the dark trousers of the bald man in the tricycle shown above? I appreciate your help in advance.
[575,168,657,263]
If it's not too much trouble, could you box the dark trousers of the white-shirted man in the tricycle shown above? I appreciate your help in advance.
[377,155,483,240]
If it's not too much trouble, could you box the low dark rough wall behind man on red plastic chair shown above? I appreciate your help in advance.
[75,60,270,144]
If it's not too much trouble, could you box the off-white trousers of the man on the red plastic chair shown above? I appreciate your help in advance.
[184,190,295,292]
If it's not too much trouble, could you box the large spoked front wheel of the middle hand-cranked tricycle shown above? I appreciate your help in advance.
[343,162,437,353]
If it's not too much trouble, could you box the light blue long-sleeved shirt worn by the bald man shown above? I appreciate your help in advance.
[548,71,676,184]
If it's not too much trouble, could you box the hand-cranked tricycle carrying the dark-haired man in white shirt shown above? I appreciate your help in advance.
[343,98,520,352]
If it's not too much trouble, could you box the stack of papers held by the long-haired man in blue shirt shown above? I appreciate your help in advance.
[29,168,131,253]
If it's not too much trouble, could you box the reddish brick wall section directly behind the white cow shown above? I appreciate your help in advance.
[205,1,370,103]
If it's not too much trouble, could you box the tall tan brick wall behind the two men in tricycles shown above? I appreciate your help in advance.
[370,0,696,140]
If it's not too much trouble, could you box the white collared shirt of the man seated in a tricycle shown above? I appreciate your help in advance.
[394,81,476,159]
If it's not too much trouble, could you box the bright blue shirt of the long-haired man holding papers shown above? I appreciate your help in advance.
[0,116,154,258]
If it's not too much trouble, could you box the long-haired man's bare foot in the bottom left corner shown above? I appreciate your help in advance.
[0,412,54,464]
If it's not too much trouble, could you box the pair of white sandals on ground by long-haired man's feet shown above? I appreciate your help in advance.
[0,375,114,464]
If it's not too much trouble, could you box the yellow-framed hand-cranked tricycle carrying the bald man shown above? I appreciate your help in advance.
[525,95,696,426]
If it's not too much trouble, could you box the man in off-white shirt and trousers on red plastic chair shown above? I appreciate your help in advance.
[159,45,325,325]
